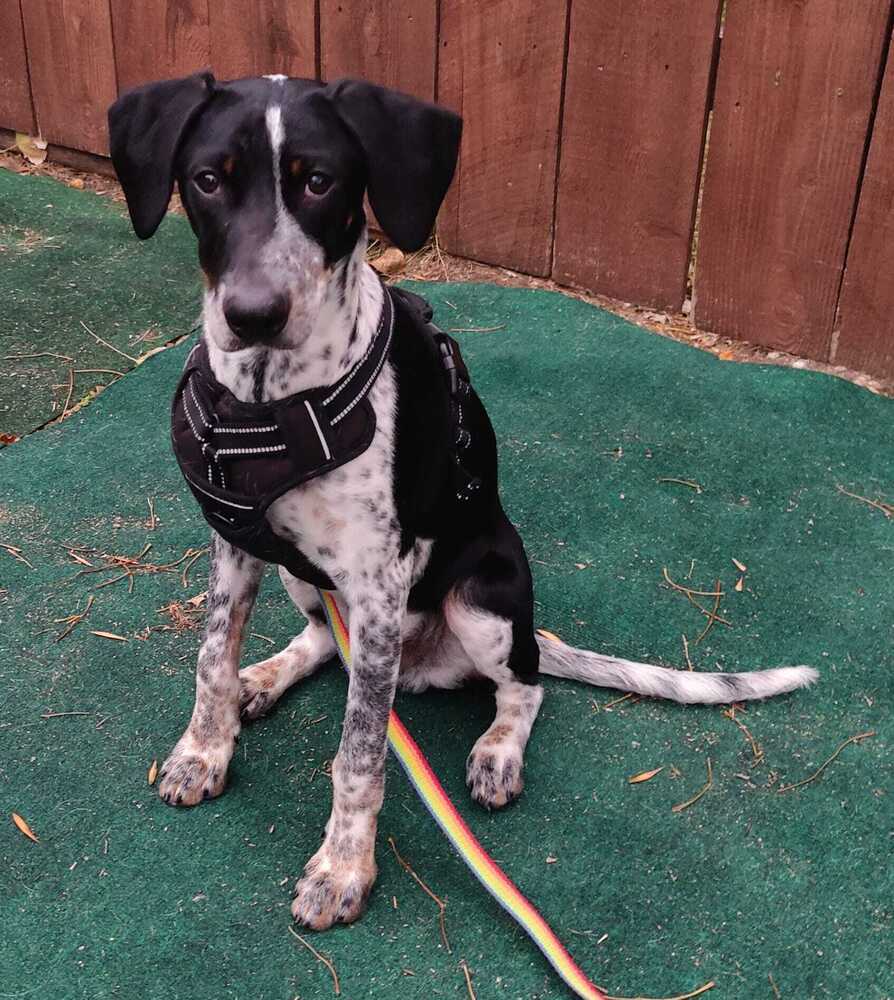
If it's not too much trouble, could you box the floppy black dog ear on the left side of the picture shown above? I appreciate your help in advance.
[109,72,214,240]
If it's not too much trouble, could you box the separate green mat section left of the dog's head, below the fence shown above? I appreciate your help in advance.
[0,169,199,444]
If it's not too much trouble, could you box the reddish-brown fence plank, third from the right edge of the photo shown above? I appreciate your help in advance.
[553,0,719,309]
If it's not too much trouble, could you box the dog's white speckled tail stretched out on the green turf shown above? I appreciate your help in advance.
[537,634,819,705]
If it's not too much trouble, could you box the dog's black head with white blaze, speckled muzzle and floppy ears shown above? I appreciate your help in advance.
[109,73,462,350]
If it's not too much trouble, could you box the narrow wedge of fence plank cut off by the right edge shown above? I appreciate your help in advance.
[829,41,894,378]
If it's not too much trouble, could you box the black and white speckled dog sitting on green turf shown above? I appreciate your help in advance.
[109,74,816,929]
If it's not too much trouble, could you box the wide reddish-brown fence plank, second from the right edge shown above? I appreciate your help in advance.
[696,0,890,359]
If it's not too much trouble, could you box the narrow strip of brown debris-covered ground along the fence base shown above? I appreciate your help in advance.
[0,143,894,397]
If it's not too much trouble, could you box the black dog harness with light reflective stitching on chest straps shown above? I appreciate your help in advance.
[171,288,481,590]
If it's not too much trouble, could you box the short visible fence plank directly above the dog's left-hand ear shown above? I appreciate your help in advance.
[110,0,211,90]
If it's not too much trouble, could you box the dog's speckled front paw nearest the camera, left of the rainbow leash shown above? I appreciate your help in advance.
[292,846,376,931]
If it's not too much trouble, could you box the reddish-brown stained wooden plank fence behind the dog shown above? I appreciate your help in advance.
[0,0,894,377]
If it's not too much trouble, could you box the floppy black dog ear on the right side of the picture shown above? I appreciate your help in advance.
[326,80,462,250]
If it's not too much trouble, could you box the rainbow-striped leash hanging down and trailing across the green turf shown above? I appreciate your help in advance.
[320,590,606,1000]
